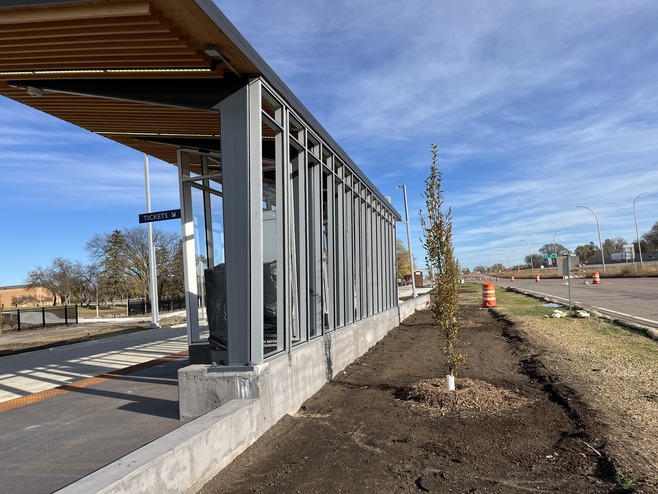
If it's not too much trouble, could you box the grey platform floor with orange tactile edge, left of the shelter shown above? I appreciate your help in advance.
[0,359,187,494]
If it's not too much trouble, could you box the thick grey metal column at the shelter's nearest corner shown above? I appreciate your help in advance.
[218,79,263,366]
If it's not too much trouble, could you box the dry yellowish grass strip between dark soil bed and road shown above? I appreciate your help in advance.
[495,290,658,492]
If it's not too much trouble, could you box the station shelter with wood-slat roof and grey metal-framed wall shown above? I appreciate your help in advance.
[0,0,418,436]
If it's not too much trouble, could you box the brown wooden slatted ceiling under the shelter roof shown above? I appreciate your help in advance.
[0,0,261,163]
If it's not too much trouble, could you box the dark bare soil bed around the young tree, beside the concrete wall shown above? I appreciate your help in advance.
[201,305,640,494]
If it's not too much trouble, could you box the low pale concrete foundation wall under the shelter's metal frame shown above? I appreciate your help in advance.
[59,302,429,494]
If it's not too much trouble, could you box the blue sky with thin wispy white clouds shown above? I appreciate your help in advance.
[0,0,658,286]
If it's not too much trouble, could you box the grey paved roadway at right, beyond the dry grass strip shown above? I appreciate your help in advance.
[494,278,658,328]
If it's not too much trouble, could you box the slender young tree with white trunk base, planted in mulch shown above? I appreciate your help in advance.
[420,144,466,389]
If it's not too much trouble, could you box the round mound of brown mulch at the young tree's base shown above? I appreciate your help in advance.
[396,378,531,416]
